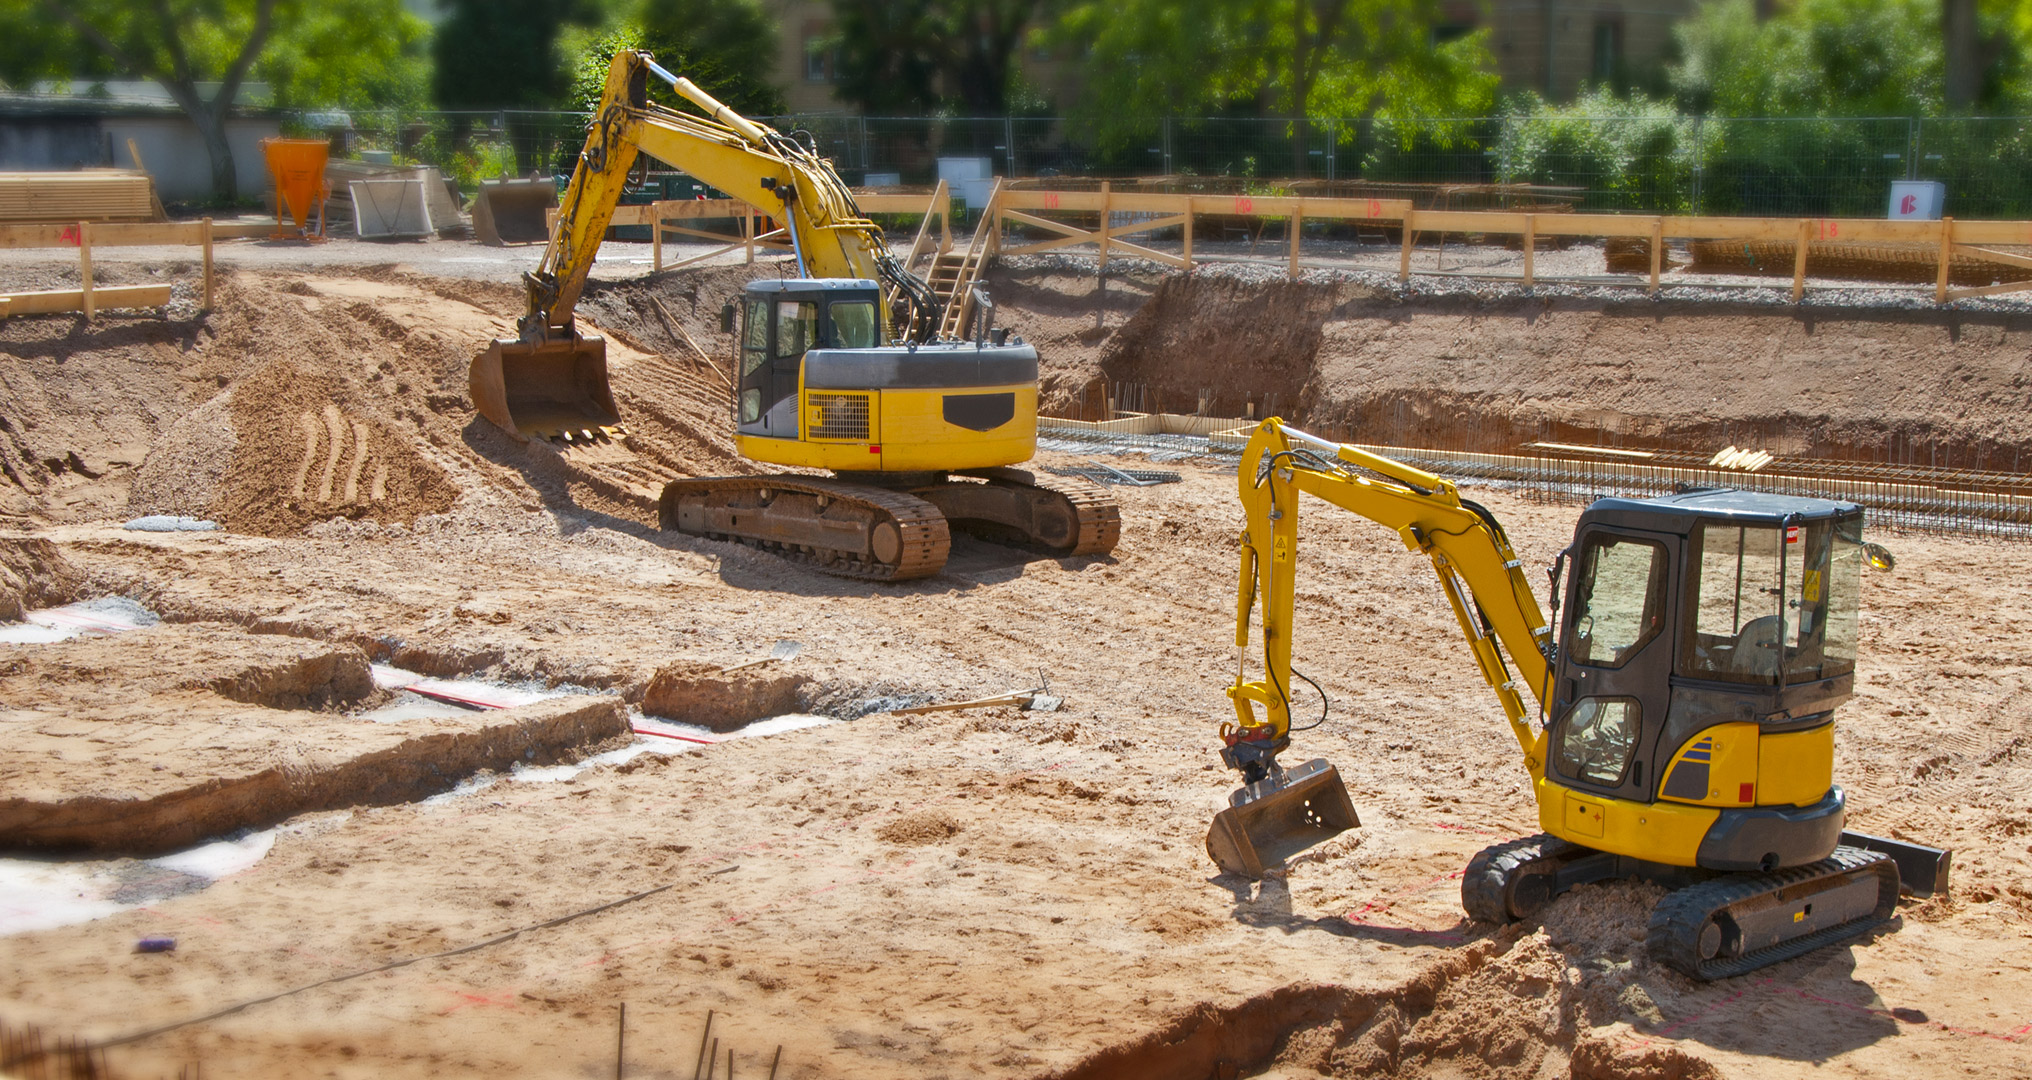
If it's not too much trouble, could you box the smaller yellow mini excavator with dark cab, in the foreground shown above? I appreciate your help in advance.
[1207,419,1951,978]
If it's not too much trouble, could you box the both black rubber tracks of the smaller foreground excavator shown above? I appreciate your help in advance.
[1461,834,1901,978]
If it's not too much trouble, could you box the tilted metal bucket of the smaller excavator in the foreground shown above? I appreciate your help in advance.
[1207,757,1361,881]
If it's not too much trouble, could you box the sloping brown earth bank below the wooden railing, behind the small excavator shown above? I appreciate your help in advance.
[1089,271,2032,470]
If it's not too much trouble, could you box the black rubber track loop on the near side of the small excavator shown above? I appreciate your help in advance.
[1644,848,1898,978]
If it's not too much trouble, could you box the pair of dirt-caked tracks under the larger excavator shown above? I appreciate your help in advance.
[658,468,1122,582]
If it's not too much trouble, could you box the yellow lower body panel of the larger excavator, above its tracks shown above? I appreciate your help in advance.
[734,382,1036,472]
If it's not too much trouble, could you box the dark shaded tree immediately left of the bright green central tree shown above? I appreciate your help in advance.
[833,0,1042,116]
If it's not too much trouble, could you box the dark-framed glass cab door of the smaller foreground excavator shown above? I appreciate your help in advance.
[1546,527,1685,801]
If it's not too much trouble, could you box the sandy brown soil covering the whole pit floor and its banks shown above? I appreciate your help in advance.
[0,249,2032,1080]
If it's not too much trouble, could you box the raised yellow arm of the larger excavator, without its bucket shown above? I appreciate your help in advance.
[522,51,935,340]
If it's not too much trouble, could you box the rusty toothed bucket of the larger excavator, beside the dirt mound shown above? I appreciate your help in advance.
[469,336,622,443]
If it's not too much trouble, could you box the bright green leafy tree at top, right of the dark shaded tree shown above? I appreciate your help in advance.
[1053,0,1498,167]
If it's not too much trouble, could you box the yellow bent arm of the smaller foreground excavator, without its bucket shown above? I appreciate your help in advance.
[1221,417,1552,779]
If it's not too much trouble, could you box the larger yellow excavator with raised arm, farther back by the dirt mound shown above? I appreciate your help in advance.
[469,51,1122,582]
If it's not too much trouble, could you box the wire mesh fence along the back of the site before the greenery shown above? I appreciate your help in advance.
[291,110,2032,220]
